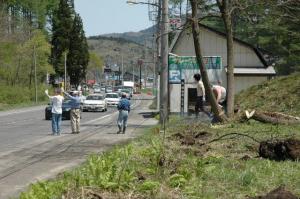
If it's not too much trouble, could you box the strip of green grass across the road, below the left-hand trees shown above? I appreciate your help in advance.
[0,85,51,111]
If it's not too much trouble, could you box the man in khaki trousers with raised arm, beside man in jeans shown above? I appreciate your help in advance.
[64,91,81,134]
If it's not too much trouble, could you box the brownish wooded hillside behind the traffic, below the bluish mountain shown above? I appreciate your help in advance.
[88,36,153,72]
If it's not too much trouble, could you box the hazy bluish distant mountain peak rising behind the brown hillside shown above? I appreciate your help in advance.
[100,26,156,48]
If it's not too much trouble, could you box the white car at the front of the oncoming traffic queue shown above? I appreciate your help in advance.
[82,94,107,112]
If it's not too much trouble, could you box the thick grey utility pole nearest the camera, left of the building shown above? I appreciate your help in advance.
[159,0,169,125]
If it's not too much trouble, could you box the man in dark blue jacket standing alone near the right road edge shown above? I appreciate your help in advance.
[117,93,130,134]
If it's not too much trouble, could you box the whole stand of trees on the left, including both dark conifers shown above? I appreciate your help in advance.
[0,0,89,88]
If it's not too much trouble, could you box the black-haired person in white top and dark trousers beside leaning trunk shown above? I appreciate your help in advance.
[194,73,210,117]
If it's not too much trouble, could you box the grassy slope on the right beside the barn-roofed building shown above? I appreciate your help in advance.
[236,73,300,116]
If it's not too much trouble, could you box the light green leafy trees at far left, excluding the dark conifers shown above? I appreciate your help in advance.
[0,0,58,86]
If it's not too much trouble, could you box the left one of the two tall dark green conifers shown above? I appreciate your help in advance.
[51,0,74,76]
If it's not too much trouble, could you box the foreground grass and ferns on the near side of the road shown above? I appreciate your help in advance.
[20,119,300,199]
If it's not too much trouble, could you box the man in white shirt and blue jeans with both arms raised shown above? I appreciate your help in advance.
[45,88,64,135]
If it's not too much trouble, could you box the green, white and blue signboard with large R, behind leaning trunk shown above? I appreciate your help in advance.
[169,55,222,84]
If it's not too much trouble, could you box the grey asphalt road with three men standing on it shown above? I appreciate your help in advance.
[0,96,156,199]
